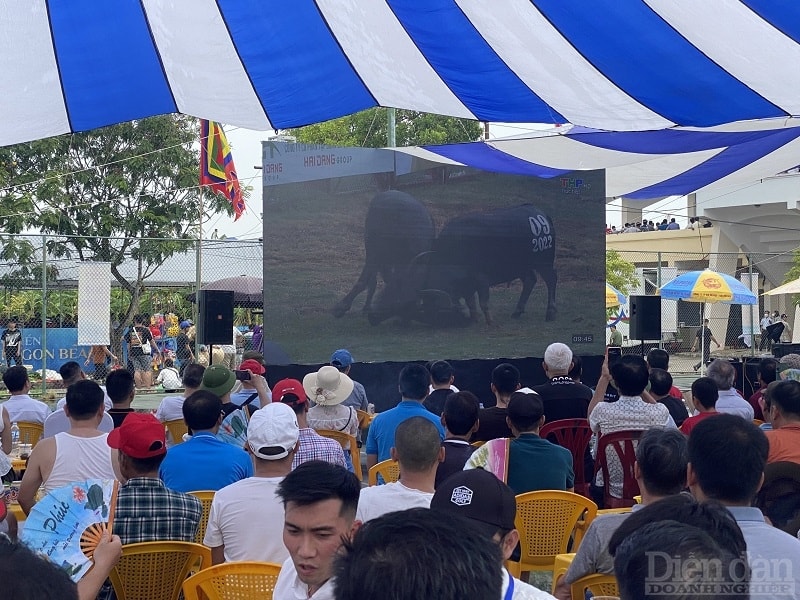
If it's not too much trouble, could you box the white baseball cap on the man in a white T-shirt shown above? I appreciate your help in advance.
[247,402,300,460]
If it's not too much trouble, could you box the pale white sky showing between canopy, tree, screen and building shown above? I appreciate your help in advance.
[217,123,688,239]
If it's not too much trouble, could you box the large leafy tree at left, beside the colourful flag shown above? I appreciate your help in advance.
[0,115,239,334]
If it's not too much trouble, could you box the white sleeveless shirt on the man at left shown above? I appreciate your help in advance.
[44,432,116,492]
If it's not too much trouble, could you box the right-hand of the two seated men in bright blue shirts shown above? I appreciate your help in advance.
[367,364,444,469]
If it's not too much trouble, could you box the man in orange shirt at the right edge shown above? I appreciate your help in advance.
[765,379,800,464]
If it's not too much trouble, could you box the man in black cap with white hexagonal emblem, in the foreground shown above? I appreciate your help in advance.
[431,469,552,600]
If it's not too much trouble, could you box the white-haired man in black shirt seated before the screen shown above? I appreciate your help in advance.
[533,342,593,423]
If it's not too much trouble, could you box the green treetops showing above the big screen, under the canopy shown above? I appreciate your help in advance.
[288,108,482,148]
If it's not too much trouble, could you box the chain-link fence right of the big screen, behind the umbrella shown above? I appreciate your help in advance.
[610,250,794,372]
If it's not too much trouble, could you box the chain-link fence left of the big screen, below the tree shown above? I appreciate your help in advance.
[0,235,263,391]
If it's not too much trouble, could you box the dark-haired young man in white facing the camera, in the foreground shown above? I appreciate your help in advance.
[272,460,361,600]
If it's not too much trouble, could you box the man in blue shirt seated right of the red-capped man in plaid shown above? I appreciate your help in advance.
[158,390,253,492]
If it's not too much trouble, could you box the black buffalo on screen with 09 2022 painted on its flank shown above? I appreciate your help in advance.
[369,204,557,324]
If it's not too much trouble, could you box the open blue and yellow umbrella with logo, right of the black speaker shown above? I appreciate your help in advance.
[658,269,758,373]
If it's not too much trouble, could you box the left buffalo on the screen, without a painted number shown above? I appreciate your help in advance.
[331,190,435,317]
